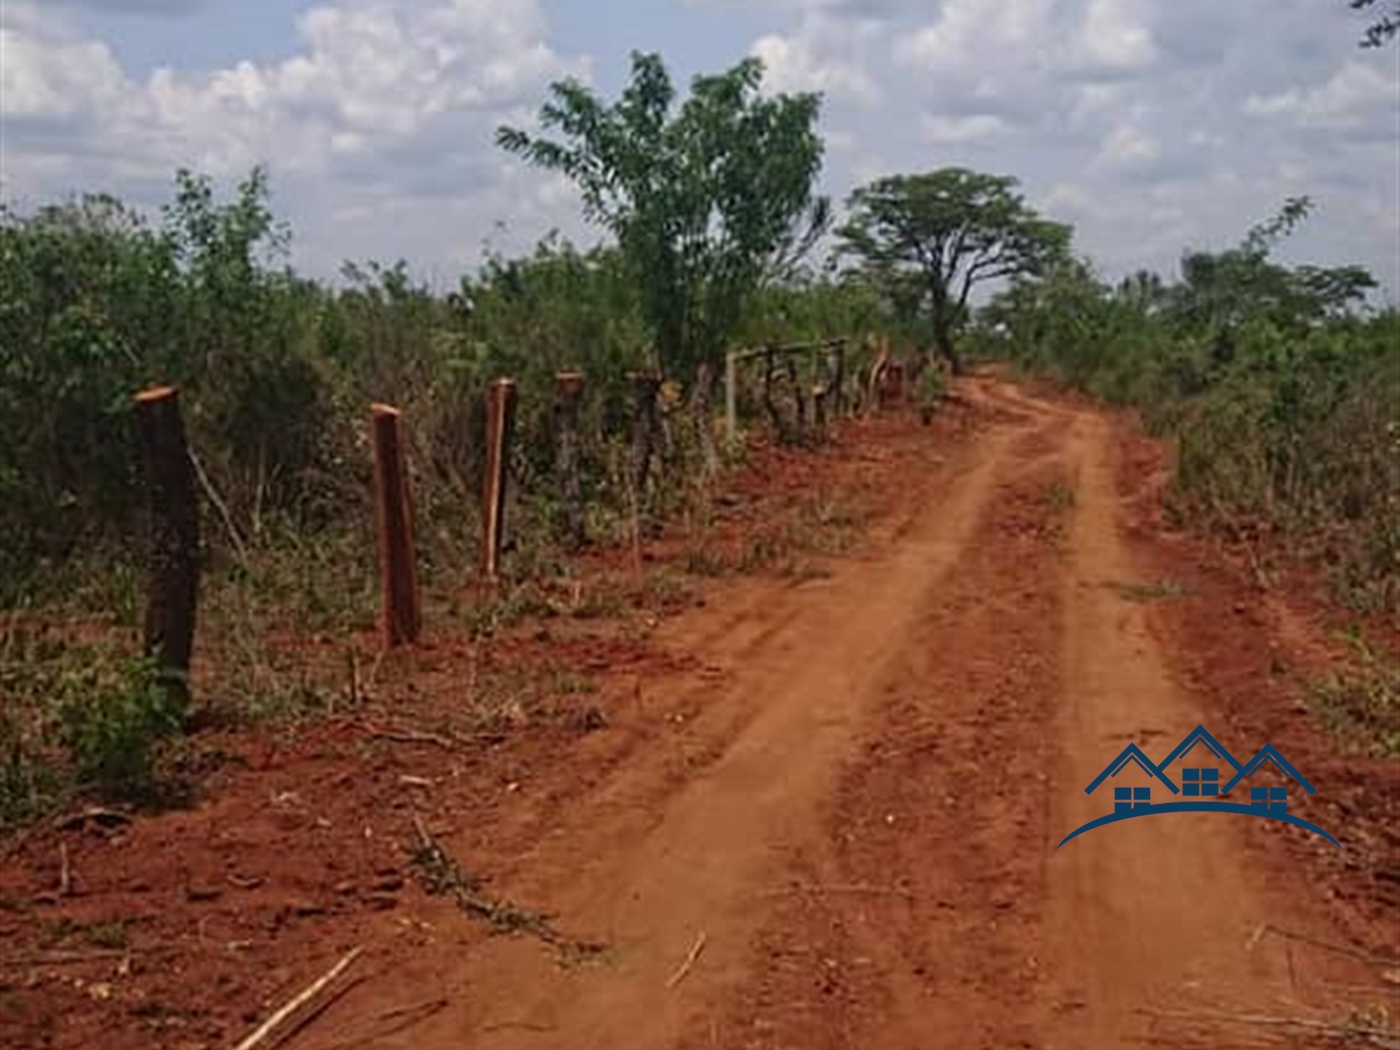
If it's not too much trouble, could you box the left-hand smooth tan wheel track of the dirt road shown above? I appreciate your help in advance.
[338,400,1052,1047]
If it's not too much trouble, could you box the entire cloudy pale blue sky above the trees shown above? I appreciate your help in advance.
[0,0,1400,300]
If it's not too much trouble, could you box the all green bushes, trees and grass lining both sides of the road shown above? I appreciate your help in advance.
[0,37,1400,827]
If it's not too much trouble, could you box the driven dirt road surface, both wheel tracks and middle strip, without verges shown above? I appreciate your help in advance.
[305,379,1383,1050]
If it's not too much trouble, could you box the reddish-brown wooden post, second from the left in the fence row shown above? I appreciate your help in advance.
[370,405,423,650]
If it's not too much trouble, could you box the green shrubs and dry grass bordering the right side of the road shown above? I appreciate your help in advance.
[977,200,1400,617]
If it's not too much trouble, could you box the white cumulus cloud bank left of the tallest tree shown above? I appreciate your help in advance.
[0,0,588,280]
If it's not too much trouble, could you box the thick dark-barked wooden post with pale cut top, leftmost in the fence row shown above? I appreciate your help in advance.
[136,386,200,701]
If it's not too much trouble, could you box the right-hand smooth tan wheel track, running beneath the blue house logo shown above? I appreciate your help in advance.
[1037,412,1372,1047]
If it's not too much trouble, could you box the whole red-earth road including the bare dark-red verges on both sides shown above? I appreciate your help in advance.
[8,377,1400,1050]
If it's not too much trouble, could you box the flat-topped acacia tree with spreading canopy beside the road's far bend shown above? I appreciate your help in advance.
[837,168,1071,371]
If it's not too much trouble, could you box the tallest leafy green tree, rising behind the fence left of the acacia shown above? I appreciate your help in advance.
[497,53,830,379]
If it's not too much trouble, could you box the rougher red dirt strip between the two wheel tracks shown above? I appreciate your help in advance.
[687,413,1064,1050]
